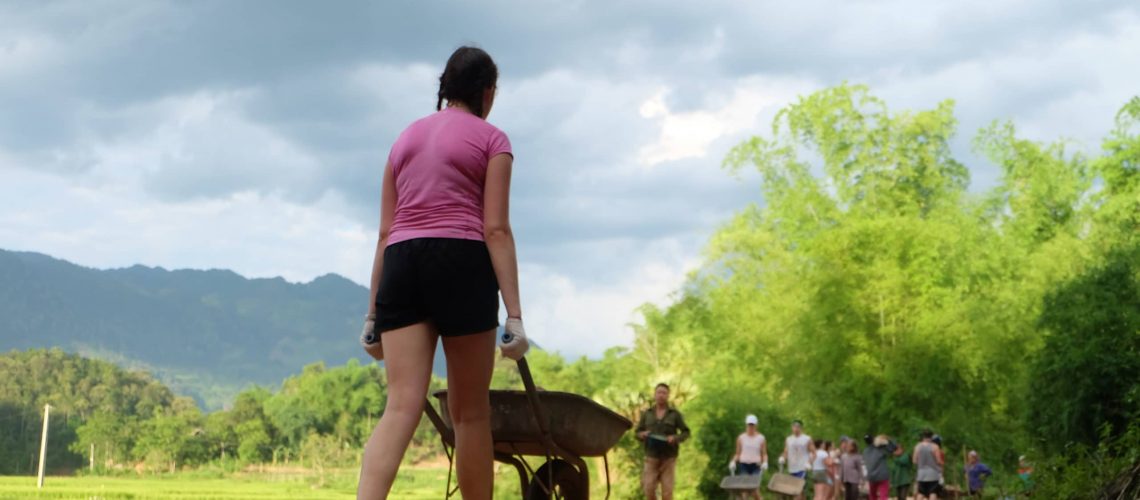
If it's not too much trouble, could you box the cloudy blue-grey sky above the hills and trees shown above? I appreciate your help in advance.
[0,0,1140,355]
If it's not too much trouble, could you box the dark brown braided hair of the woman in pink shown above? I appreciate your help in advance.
[435,47,498,117]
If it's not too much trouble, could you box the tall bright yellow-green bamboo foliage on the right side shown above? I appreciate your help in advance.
[601,85,1140,495]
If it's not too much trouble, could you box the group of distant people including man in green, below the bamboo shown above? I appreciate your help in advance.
[635,384,993,500]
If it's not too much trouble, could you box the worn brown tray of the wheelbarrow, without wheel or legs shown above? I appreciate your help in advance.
[432,391,633,457]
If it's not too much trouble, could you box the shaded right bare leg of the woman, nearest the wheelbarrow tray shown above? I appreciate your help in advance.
[443,330,495,500]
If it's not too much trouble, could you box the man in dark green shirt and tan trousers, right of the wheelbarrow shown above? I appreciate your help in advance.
[637,384,689,500]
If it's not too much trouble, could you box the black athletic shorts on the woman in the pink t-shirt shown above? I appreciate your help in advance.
[376,238,498,336]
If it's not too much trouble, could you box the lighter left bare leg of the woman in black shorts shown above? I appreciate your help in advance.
[357,323,437,500]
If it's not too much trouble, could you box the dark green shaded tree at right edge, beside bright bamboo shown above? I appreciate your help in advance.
[1027,252,1140,452]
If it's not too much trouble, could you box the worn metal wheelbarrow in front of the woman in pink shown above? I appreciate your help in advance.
[424,358,633,500]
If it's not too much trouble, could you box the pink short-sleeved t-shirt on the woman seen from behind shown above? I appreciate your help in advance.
[388,108,511,245]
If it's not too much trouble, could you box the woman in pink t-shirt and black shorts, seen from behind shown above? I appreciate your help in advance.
[357,47,527,500]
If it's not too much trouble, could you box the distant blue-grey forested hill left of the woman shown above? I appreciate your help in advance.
[0,251,442,409]
